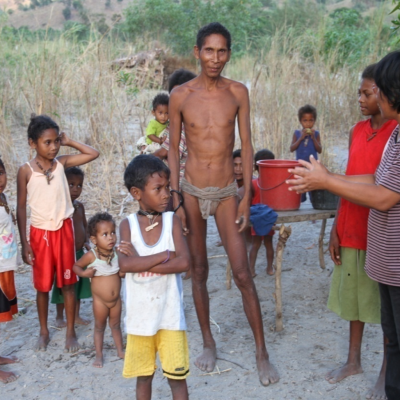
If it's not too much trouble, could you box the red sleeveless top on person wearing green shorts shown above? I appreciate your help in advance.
[337,119,397,250]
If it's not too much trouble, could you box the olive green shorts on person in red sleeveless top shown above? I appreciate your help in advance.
[328,247,381,324]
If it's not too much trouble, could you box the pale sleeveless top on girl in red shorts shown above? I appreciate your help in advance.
[26,159,74,231]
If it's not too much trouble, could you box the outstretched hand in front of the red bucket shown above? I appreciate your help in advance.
[286,156,330,193]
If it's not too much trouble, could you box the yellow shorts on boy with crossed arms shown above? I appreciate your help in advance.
[122,329,189,380]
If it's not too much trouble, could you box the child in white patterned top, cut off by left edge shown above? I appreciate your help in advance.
[0,158,19,383]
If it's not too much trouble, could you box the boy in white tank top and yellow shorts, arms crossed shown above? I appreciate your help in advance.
[119,155,190,400]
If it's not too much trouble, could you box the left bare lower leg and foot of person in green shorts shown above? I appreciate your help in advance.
[325,321,365,384]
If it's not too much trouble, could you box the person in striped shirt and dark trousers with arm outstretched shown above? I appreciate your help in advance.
[287,51,400,400]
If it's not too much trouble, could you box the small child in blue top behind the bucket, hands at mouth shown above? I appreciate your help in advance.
[290,104,322,202]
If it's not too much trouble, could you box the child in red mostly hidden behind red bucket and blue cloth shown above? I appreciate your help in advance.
[249,149,275,277]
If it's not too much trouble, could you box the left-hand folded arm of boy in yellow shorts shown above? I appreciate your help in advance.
[117,218,168,273]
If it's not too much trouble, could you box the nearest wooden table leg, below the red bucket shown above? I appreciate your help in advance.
[275,224,292,332]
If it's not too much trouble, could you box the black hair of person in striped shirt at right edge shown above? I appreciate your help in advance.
[374,51,400,113]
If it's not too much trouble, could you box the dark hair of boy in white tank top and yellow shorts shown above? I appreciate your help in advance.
[124,154,170,191]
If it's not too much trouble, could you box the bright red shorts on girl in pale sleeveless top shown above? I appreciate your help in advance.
[30,218,78,292]
